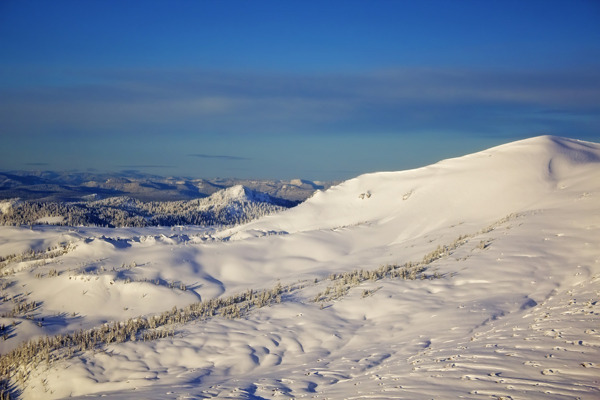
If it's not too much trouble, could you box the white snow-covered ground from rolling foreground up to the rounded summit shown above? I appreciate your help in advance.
[0,136,600,399]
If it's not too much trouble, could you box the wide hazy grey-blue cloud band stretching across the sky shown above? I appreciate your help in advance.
[0,68,600,141]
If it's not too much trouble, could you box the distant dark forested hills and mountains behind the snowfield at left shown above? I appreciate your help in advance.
[0,172,338,227]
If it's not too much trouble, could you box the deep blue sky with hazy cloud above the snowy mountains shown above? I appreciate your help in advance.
[0,0,600,180]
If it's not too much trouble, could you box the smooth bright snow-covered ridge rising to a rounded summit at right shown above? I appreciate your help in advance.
[223,136,600,238]
